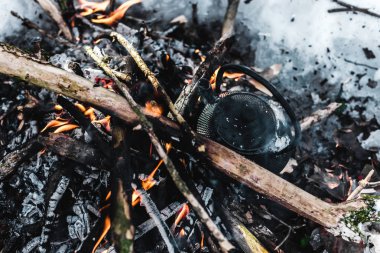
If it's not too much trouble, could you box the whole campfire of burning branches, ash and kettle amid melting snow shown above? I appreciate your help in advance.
[0,0,380,253]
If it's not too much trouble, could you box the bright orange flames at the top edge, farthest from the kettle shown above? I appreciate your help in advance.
[79,0,142,26]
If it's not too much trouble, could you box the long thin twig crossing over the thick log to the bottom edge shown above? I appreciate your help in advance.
[85,46,234,252]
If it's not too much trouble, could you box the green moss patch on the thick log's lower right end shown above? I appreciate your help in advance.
[343,195,380,234]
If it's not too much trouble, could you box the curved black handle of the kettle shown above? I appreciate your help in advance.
[216,64,301,152]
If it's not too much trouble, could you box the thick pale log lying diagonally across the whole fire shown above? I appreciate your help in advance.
[0,44,365,228]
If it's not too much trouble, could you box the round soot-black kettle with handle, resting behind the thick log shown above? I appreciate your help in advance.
[197,64,300,173]
